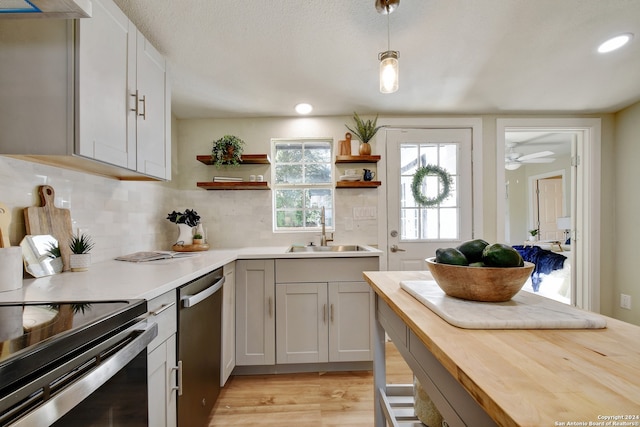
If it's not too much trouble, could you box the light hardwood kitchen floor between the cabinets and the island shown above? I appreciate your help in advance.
[209,342,413,427]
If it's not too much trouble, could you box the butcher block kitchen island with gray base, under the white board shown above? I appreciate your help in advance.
[364,271,640,427]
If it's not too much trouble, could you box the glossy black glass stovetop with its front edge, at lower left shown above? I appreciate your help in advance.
[0,300,147,391]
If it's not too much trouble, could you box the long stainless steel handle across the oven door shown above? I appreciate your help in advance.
[10,321,158,427]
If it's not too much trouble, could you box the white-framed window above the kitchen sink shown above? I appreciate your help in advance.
[272,139,333,231]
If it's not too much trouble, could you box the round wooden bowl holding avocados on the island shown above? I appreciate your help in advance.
[425,258,535,302]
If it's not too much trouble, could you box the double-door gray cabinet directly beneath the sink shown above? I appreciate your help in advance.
[276,258,378,364]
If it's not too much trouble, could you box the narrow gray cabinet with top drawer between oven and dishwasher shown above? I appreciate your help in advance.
[147,290,178,427]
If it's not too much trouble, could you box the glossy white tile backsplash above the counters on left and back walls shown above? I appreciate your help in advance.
[0,156,377,262]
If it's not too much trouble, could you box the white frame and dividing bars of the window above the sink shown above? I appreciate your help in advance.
[271,137,336,233]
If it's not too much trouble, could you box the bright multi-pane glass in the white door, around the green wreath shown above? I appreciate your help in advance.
[399,142,460,241]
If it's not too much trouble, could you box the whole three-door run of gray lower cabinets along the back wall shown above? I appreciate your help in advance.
[235,257,379,367]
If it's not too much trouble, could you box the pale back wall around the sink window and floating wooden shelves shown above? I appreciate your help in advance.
[177,117,381,247]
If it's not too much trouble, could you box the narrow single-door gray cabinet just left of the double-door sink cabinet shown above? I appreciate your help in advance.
[236,259,276,366]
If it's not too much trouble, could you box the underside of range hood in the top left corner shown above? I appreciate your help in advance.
[0,0,91,19]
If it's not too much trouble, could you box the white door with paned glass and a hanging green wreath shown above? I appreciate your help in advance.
[386,128,473,270]
